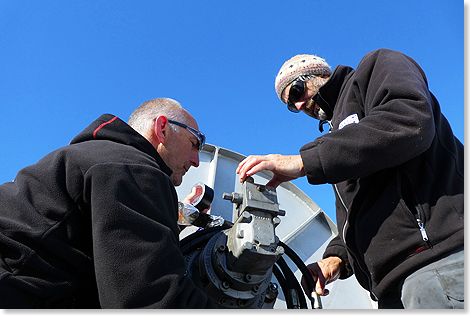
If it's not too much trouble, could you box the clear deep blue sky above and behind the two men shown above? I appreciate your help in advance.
[0,0,464,225]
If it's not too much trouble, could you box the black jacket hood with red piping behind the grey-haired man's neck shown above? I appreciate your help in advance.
[70,114,173,176]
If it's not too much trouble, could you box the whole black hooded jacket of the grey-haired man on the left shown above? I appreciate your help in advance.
[0,115,214,309]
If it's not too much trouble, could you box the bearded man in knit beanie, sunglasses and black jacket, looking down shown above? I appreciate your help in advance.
[237,49,464,308]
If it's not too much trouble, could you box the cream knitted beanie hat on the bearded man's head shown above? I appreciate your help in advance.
[275,55,331,101]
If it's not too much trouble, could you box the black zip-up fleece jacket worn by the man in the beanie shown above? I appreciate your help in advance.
[300,49,464,299]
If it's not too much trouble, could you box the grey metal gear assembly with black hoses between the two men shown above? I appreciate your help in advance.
[179,177,321,309]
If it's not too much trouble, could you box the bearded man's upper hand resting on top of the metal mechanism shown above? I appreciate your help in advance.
[236,154,305,188]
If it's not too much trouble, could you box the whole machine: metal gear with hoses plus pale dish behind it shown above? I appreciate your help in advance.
[176,143,377,309]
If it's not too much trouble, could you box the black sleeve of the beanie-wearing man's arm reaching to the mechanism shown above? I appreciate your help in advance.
[300,50,435,184]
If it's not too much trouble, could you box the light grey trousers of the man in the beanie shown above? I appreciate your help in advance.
[379,248,464,309]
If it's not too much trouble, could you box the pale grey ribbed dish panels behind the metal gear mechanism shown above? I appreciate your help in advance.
[177,144,377,309]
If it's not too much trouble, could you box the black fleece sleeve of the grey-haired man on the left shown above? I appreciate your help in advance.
[84,163,215,308]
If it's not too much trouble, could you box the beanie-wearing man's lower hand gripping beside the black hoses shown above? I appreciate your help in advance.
[301,256,343,296]
